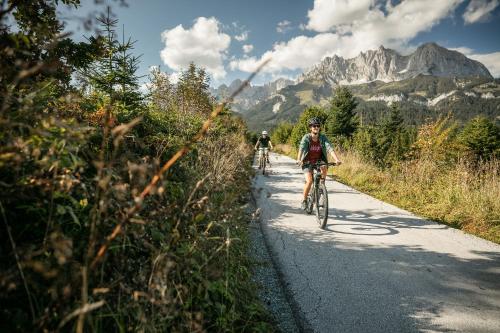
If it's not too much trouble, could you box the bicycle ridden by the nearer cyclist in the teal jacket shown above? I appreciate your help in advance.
[306,161,337,229]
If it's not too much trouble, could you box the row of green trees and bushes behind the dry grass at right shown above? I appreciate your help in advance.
[272,86,500,169]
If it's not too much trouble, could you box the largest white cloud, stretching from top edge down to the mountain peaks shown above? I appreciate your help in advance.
[230,0,463,72]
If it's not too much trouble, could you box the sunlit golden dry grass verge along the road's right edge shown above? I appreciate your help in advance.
[336,152,500,243]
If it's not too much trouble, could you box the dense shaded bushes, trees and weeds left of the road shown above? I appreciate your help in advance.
[0,0,274,332]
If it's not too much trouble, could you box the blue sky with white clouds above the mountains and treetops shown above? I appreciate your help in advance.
[59,0,500,86]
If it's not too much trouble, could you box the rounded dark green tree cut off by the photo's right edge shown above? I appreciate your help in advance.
[458,116,500,160]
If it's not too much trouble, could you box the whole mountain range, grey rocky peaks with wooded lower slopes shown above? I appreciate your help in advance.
[213,43,500,130]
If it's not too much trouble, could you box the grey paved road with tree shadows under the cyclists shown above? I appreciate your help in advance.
[254,154,500,333]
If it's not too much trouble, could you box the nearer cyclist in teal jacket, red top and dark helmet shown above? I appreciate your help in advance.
[297,118,342,209]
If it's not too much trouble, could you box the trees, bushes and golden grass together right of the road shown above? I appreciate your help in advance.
[271,87,500,243]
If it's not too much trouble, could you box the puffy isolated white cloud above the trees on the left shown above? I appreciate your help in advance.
[160,17,231,79]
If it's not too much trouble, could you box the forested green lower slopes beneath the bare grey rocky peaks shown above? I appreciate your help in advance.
[243,75,500,131]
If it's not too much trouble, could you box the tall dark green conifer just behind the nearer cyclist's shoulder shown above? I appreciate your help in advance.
[326,86,359,139]
